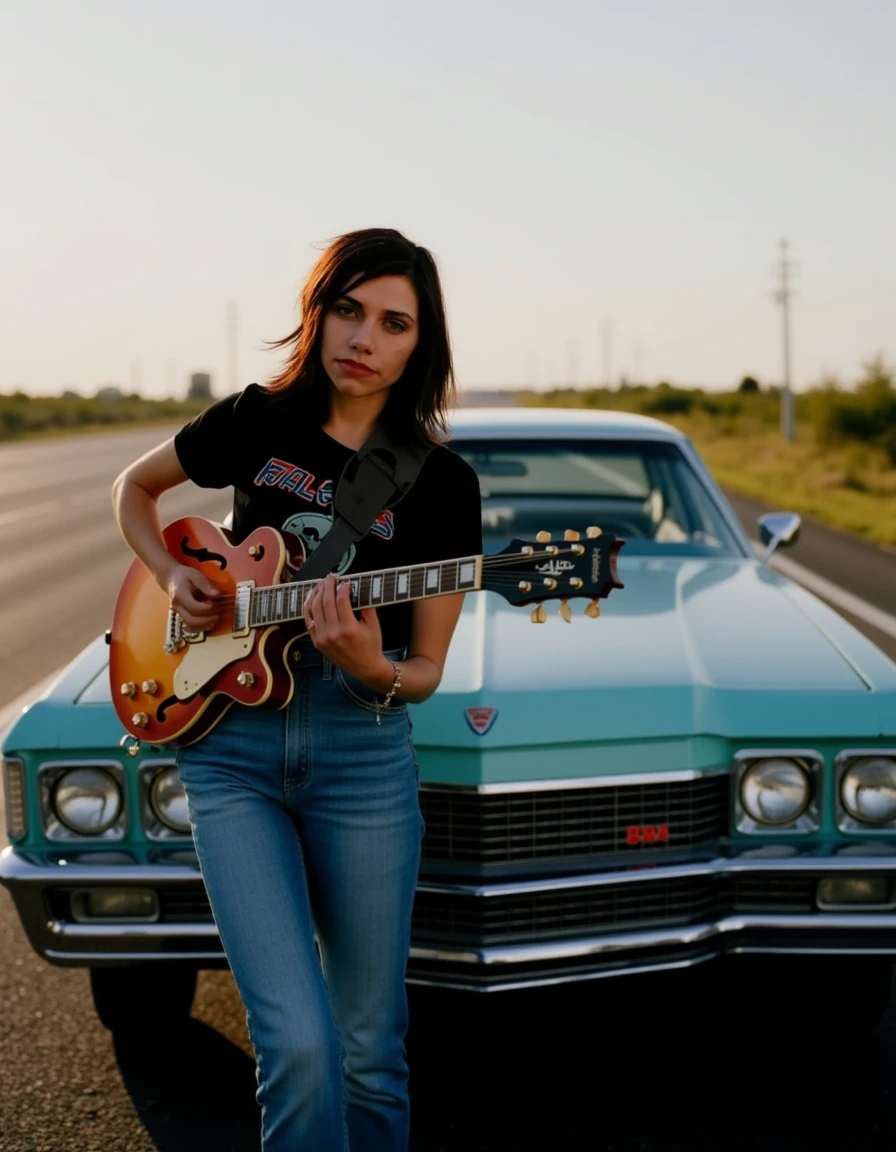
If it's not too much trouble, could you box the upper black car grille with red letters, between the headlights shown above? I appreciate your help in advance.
[420,773,730,869]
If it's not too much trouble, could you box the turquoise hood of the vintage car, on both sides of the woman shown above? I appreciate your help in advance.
[3,558,896,782]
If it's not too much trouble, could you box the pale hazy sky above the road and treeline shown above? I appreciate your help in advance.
[0,0,896,397]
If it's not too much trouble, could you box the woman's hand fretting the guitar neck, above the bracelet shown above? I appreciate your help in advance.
[304,573,392,681]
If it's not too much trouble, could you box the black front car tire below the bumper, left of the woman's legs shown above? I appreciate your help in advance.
[90,964,197,1036]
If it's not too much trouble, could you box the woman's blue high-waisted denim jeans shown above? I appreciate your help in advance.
[177,641,423,1152]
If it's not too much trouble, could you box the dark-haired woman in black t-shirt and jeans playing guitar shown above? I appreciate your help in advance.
[114,229,481,1152]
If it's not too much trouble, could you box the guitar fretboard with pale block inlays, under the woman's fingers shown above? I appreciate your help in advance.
[244,556,483,628]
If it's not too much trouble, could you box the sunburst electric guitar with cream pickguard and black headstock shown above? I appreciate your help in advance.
[109,516,624,755]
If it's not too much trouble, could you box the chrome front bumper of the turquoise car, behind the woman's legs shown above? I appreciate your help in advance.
[0,842,896,992]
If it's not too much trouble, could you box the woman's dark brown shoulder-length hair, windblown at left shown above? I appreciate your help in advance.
[267,228,455,441]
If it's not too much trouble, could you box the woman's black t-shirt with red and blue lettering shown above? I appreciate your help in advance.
[174,384,483,651]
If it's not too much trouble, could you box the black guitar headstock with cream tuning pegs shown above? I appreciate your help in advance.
[483,528,625,624]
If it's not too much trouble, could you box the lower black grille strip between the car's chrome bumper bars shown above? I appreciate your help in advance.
[412,876,814,945]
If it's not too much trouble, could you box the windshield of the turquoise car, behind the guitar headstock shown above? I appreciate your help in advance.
[451,439,744,556]
